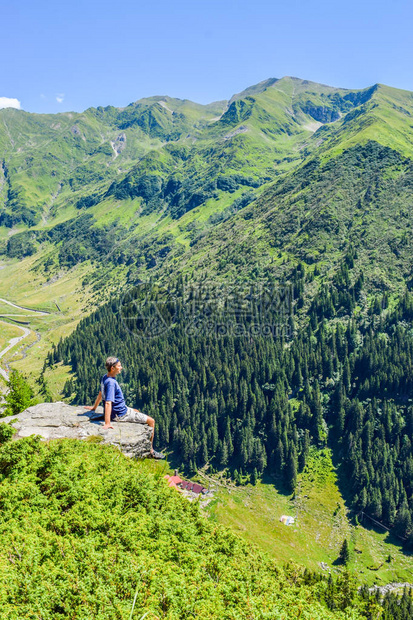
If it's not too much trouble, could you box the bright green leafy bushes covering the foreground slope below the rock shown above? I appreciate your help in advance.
[0,437,366,620]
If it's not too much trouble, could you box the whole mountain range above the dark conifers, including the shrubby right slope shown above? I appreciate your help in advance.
[0,77,413,367]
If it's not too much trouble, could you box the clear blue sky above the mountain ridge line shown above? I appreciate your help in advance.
[0,0,413,112]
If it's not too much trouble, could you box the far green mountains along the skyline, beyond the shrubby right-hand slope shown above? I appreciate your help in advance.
[0,78,412,256]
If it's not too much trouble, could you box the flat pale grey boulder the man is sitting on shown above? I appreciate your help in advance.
[1,402,151,458]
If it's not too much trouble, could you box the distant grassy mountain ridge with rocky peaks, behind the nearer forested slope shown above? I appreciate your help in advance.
[0,78,412,290]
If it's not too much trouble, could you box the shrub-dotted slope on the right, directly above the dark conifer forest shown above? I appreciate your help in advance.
[177,141,413,291]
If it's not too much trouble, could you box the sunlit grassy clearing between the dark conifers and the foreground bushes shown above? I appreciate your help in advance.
[204,450,413,586]
